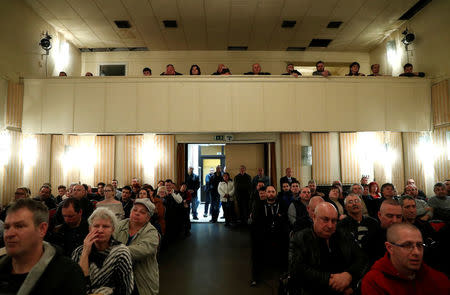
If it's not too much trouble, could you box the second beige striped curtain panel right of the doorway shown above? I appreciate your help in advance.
[311,133,333,185]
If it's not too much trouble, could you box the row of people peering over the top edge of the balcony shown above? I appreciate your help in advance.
[59,61,425,77]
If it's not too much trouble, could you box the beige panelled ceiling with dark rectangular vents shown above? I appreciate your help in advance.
[26,0,417,51]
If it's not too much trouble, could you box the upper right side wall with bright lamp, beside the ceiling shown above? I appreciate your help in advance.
[370,0,450,80]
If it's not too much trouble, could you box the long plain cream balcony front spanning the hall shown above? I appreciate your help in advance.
[22,76,431,134]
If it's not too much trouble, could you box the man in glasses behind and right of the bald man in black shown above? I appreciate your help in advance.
[338,193,380,263]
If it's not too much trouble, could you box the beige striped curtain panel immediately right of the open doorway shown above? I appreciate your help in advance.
[282,133,302,183]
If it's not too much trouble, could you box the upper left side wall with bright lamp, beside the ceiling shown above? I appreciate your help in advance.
[0,0,81,80]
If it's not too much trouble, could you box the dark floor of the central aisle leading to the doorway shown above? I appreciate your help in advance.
[159,223,278,295]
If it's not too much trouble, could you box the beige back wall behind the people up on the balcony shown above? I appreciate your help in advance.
[82,51,370,76]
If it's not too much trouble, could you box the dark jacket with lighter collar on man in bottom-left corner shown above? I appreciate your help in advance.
[0,242,86,295]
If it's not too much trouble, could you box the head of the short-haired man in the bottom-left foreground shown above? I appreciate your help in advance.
[3,199,48,258]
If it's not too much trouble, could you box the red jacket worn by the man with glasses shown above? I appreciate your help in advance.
[361,253,450,295]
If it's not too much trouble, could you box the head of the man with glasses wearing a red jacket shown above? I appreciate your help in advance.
[385,223,424,277]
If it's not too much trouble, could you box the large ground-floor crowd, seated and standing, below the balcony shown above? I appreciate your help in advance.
[0,165,450,295]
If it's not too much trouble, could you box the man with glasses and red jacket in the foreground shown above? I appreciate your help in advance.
[362,223,450,295]
